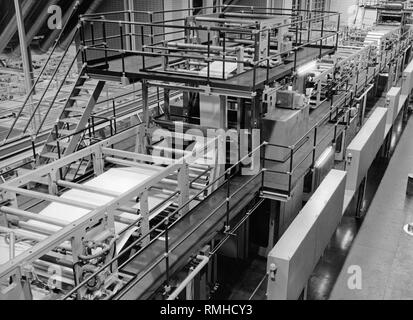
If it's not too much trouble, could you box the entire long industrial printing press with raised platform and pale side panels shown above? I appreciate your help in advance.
[0,5,413,300]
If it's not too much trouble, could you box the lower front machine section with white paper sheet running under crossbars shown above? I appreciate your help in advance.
[0,127,222,300]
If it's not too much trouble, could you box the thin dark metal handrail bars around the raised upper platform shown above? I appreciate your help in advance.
[81,10,340,89]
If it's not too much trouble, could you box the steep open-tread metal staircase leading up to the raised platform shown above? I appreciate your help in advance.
[39,66,105,165]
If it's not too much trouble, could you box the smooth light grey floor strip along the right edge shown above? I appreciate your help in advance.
[330,111,413,300]
